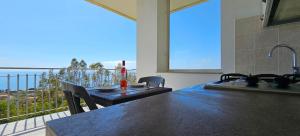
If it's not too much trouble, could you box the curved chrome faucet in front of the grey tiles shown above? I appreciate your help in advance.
[269,43,300,74]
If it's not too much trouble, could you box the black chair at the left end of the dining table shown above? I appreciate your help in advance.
[62,81,98,115]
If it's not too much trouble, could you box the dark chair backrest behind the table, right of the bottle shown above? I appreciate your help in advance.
[138,76,165,87]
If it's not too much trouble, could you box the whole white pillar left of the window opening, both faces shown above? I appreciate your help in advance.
[137,0,170,77]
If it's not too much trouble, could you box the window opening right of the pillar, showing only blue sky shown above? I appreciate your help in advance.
[169,0,221,70]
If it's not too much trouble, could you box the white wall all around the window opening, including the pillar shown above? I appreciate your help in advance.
[137,0,261,90]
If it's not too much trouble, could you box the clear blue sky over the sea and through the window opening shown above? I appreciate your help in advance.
[0,0,220,68]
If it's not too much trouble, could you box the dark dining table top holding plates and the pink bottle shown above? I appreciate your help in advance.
[87,87,172,106]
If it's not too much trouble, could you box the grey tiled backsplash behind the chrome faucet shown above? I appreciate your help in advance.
[235,16,300,75]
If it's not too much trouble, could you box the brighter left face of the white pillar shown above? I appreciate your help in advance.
[136,0,157,77]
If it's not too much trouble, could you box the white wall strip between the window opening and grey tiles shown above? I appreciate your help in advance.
[221,0,262,73]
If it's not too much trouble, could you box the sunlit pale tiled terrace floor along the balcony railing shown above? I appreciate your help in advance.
[0,106,101,136]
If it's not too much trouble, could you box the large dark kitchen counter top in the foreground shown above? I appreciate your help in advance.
[46,85,300,136]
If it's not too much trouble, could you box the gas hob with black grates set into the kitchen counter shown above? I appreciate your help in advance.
[204,73,300,95]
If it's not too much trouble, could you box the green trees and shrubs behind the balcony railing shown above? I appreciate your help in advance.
[0,58,136,124]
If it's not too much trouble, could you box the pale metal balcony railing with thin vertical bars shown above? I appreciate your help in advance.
[0,67,136,124]
